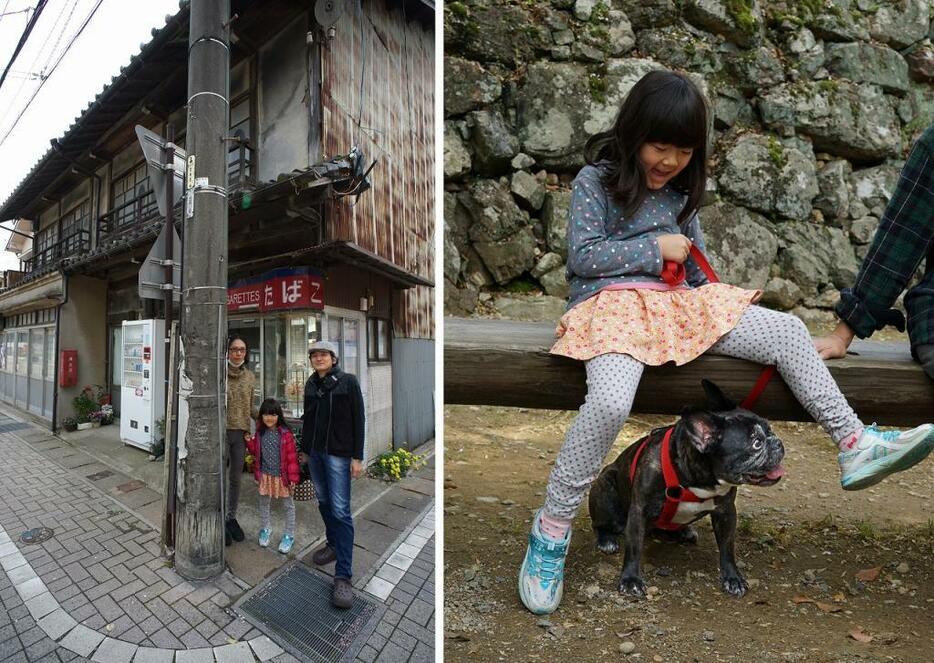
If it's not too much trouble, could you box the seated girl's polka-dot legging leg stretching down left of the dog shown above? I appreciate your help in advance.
[544,354,644,520]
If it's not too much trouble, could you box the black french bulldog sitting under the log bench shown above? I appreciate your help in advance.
[590,380,785,597]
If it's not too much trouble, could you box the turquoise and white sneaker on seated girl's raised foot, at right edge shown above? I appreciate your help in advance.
[837,424,934,490]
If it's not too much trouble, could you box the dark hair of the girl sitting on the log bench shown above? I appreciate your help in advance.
[584,71,707,225]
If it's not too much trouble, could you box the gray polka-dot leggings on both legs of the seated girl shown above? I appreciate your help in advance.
[545,306,863,520]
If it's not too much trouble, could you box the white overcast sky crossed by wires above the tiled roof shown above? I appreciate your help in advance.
[0,0,178,270]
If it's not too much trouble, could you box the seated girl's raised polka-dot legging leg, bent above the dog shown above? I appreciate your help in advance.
[708,306,863,443]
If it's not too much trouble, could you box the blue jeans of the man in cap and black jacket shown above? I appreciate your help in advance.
[308,450,353,580]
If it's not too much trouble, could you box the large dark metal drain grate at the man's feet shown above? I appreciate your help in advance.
[240,564,381,663]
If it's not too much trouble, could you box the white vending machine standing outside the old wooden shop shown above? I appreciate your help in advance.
[115,320,165,451]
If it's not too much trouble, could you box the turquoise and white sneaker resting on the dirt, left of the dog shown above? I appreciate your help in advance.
[519,513,571,615]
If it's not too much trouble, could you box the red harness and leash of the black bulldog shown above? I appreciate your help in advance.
[629,244,775,531]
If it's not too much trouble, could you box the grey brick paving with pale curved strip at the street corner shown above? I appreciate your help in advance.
[0,415,434,663]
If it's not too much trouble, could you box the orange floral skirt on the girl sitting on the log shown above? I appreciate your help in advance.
[551,283,760,366]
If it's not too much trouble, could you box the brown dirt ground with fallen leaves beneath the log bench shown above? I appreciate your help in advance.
[444,406,934,663]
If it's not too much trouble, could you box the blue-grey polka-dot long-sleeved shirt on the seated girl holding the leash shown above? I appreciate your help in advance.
[567,166,707,309]
